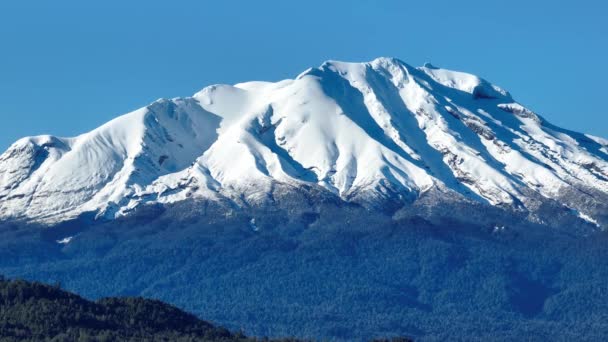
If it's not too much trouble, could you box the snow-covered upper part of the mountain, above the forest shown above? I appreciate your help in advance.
[0,58,608,227]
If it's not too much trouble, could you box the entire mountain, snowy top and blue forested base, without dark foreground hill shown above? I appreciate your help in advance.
[0,58,608,341]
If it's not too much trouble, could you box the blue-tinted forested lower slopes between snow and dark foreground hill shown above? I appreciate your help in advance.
[0,201,608,341]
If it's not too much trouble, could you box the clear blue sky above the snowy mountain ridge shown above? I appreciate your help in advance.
[0,0,608,150]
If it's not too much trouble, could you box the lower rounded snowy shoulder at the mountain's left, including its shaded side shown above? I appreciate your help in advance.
[0,99,220,220]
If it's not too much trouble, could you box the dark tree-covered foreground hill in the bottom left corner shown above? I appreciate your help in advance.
[0,278,250,341]
